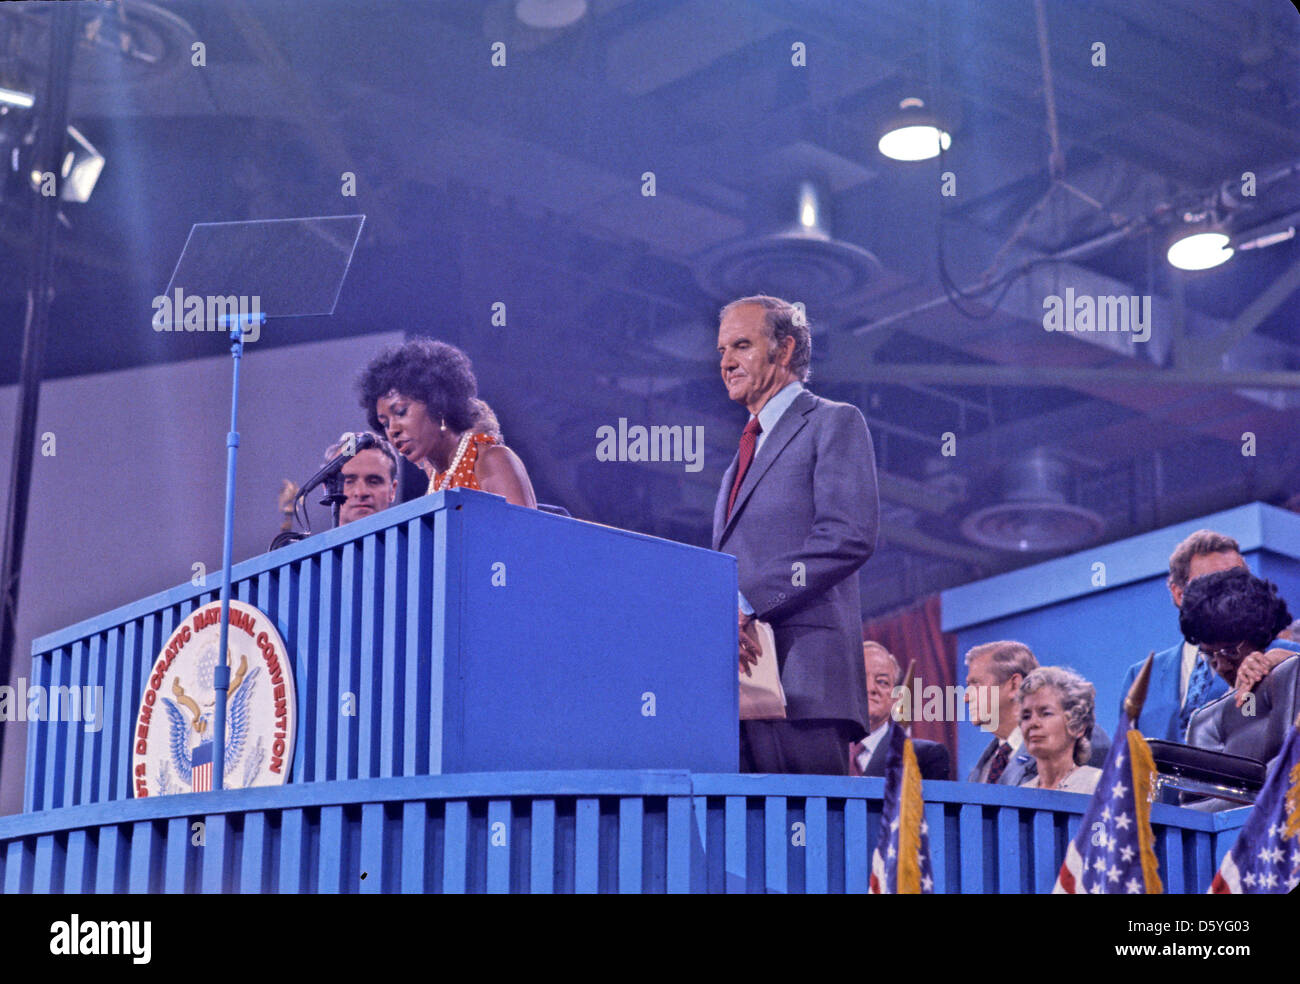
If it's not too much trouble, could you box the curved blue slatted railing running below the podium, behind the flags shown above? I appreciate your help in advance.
[0,771,1247,893]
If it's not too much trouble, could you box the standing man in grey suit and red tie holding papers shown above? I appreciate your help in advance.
[712,295,879,776]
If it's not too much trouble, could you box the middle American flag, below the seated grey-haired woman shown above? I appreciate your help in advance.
[1052,719,1164,896]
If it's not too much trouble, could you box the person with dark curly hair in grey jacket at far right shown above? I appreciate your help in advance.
[1178,568,1300,763]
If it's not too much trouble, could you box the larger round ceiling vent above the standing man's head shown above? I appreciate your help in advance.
[696,178,880,309]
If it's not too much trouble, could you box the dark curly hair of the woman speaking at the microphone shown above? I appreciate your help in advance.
[356,338,478,434]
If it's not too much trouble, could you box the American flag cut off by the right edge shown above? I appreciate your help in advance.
[1209,727,1300,896]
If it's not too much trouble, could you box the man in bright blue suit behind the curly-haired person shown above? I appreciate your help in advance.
[1118,529,1245,741]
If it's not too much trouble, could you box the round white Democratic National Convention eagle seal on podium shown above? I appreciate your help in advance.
[131,601,298,797]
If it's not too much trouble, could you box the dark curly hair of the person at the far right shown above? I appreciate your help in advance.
[1178,567,1291,649]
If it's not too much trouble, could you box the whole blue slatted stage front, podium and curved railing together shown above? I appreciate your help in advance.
[0,490,1245,893]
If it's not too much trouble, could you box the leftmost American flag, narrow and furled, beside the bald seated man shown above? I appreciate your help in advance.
[867,725,935,896]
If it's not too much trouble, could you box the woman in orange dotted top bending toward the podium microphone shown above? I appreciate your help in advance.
[358,338,537,508]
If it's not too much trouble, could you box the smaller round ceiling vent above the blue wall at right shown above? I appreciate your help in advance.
[962,448,1105,554]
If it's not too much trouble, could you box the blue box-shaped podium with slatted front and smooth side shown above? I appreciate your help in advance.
[25,490,737,811]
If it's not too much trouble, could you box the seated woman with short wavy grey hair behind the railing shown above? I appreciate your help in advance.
[1021,667,1101,793]
